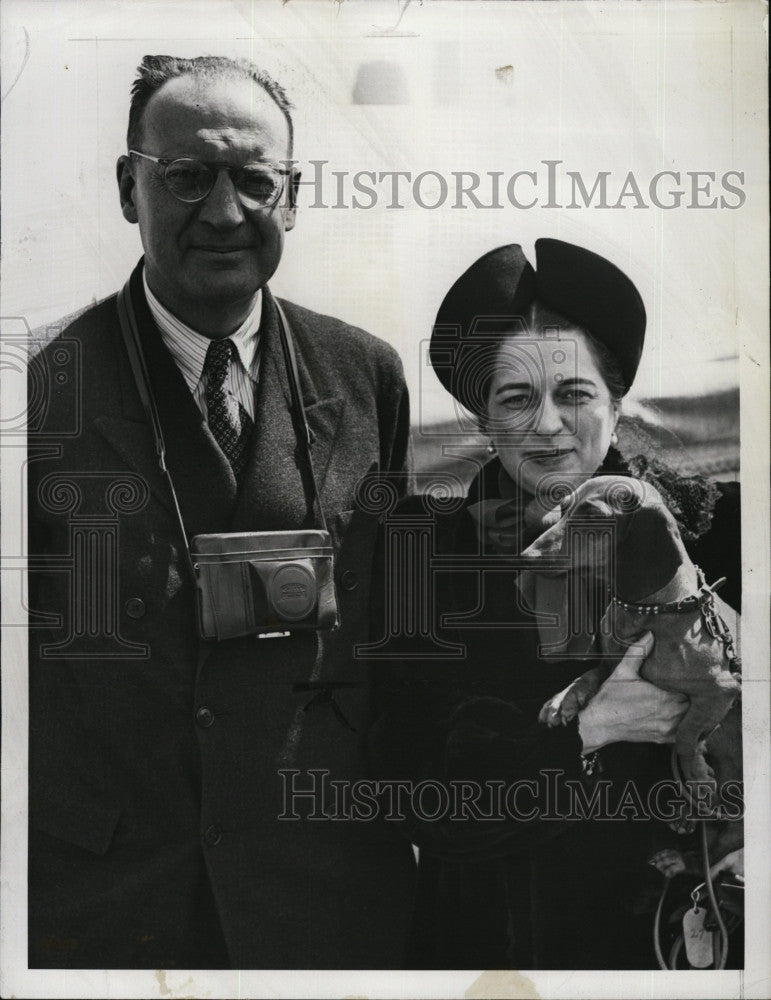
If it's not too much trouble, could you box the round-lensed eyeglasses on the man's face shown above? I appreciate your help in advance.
[129,149,290,208]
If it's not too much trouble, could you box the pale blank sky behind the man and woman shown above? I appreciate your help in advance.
[2,0,767,423]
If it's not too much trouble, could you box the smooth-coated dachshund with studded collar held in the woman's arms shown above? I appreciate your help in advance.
[522,476,741,799]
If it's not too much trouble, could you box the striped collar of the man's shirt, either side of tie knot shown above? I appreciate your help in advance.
[142,270,262,392]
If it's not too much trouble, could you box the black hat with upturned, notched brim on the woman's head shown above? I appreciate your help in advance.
[429,239,645,415]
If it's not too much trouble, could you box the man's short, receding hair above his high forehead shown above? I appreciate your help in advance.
[127,56,294,156]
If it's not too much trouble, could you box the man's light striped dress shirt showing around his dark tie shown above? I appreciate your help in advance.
[142,272,262,420]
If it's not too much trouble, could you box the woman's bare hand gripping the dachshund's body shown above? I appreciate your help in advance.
[578,632,689,754]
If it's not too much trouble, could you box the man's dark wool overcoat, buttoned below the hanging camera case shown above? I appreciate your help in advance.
[29,258,413,968]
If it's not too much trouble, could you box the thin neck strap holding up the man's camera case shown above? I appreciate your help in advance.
[117,280,327,548]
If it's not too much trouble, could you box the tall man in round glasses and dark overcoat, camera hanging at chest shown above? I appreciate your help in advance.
[29,56,412,968]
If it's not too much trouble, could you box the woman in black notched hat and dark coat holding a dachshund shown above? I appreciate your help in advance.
[369,239,740,969]
